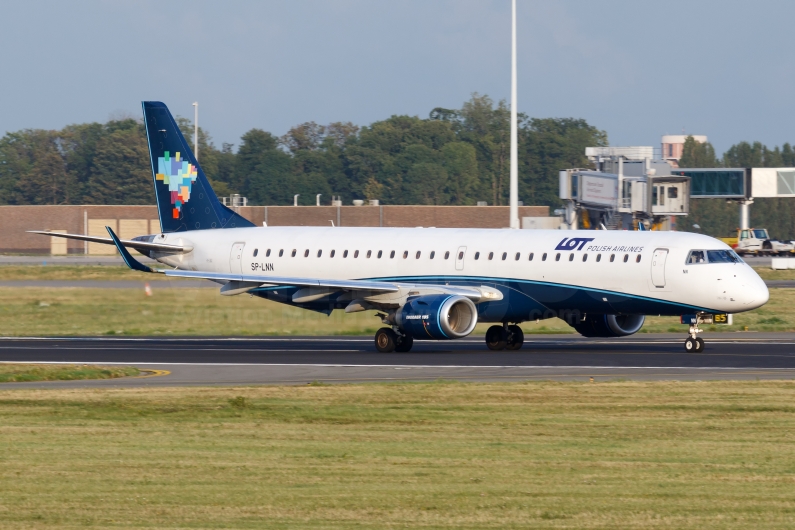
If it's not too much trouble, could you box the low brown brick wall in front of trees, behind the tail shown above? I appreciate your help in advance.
[0,205,549,254]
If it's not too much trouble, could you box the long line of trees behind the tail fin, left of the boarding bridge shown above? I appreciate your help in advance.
[0,94,607,208]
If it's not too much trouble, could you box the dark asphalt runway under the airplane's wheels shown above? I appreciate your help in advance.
[0,333,795,389]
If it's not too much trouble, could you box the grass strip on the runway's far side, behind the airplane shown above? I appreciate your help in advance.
[0,266,795,336]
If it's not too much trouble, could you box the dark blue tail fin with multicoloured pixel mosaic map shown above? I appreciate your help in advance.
[143,101,254,232]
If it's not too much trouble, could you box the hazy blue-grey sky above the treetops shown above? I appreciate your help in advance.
[0,0,795,153]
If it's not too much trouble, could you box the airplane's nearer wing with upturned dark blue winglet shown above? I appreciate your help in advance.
[99,226,502,303]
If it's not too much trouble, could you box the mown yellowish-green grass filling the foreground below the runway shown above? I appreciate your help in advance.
[0,381,795,529]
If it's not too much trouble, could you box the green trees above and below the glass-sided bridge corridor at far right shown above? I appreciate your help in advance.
[677,136,795,239]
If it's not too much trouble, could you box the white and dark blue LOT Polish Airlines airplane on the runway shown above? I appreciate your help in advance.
[31,101,769,353]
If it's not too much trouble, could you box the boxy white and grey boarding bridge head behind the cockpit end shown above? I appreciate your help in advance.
[560,147,690,230]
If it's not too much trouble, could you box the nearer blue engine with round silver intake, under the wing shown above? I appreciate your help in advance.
[395,295,478,340]
